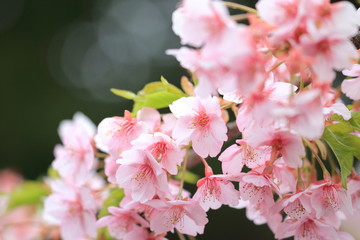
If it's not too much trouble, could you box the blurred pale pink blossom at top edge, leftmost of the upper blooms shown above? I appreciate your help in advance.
[172,0,233,47]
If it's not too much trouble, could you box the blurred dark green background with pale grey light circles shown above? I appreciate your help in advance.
[0,0,359,239]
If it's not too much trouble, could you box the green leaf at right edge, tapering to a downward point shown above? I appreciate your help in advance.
[322,128,360,189]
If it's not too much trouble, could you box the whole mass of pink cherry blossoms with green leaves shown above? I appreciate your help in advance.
[2,0,360,240]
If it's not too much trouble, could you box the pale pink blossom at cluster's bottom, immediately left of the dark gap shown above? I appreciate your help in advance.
[146,200,208,236]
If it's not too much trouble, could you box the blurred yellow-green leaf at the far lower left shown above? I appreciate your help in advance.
[7,181,50,210]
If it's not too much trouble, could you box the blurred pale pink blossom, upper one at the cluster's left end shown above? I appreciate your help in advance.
[52,113,97,185]
